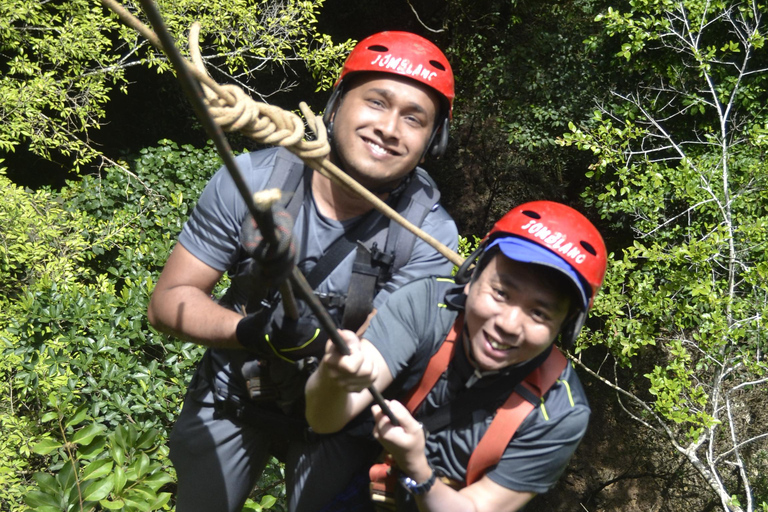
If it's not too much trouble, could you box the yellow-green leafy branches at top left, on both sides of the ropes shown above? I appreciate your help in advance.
[0,0,351,169]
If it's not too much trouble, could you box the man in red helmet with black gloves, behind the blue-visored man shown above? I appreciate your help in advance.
[148,32,458,512]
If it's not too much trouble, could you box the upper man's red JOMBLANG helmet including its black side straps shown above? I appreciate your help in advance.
[323,31,455,156]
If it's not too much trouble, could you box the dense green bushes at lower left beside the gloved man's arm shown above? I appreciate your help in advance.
[0,141,282,511]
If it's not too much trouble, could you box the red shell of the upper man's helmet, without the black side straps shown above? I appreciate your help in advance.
[335,31,454,117]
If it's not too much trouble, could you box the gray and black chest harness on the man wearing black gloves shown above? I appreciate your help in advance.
[217,148,440,428]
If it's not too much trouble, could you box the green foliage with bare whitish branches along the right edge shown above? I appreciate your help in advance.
[562,0,768,510]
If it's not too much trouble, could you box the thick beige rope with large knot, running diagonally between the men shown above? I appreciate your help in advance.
[101,0,464,266]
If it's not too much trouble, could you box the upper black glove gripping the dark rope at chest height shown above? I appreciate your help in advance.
[240,205,296,286]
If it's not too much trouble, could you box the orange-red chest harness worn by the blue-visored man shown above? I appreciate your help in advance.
[369,313,568,510]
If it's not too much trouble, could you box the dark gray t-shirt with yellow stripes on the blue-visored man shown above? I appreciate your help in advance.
[364,278,590,493]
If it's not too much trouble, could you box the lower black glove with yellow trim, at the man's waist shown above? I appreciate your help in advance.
[237,301,328,362]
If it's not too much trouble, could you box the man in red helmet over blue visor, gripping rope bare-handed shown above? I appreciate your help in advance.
[306,201,606,512]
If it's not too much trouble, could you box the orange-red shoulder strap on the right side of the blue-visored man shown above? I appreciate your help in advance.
[467,347,568,485]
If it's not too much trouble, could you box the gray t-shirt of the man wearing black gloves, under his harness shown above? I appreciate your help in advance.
[179,148,458,397]
